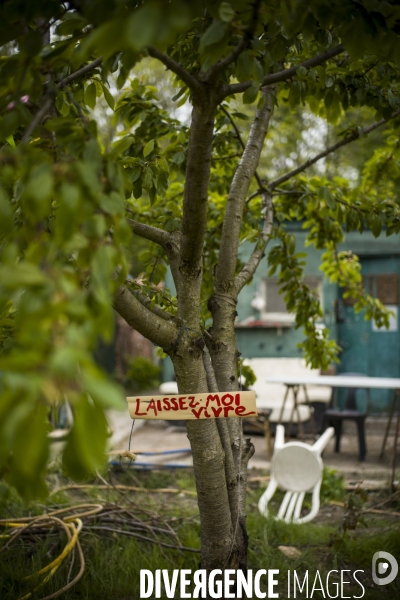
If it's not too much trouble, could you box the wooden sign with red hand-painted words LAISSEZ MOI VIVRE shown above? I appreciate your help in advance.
[127,392,257,420]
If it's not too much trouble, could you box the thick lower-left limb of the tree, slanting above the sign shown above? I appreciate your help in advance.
[113,286,178,348]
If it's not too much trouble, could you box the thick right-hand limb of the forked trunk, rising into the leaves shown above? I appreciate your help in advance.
[215,87,275,294]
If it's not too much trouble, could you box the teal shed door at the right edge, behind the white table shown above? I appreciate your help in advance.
[338,257,400,413]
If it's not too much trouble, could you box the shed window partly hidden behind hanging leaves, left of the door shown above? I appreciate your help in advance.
[261,277,323,323]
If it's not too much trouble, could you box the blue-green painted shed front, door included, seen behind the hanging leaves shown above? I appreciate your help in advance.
[163,224,400,412]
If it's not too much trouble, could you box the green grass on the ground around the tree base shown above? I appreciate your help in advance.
[0,469,400,600]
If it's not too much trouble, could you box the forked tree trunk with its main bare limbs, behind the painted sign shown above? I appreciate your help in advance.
[115,81,274,570]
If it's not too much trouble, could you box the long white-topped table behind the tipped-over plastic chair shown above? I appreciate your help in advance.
[267,375,400,488]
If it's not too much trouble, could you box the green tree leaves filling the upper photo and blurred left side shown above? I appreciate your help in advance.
[0,0,400,498]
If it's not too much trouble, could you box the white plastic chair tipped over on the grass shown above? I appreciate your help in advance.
[258,425,335,523]
